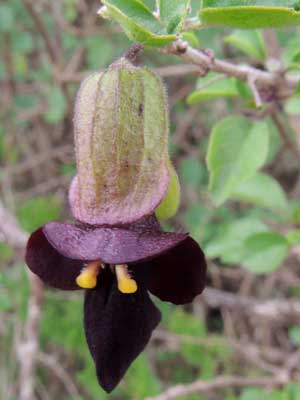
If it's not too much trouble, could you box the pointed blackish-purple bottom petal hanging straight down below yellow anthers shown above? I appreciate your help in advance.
[84,271,161,392]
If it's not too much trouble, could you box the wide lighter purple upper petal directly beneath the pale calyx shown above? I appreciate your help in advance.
[43,217,187,264]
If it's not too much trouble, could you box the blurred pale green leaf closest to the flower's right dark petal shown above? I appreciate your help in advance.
[205,217,268,264]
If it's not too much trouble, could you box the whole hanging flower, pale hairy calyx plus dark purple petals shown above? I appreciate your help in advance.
[26,52,206,392]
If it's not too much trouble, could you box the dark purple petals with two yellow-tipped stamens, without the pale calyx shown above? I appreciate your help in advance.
[26,215,206,392]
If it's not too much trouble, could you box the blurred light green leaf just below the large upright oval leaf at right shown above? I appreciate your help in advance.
[231,173,287,211]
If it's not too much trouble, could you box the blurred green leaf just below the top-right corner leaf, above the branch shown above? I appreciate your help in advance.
[224,30,266,61]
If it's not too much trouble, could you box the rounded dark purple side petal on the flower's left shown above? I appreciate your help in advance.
[26,228,83,290]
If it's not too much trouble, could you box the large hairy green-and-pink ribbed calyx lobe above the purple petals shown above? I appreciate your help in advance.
[69,58,170,225]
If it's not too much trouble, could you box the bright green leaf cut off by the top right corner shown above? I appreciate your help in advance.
[200,0,300,29]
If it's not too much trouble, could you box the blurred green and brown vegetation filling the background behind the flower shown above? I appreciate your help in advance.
[0,0,300,400]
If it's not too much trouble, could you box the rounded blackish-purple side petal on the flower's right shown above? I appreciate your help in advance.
[145,237,206,304]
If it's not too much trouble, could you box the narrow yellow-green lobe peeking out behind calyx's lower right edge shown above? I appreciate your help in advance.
[155,160,180,220]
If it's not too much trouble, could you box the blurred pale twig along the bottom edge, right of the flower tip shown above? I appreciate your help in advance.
[146,376,287,400]
